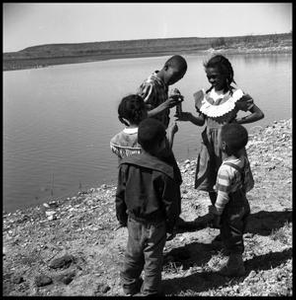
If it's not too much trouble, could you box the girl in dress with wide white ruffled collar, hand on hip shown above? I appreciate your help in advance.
[177,55,264,205]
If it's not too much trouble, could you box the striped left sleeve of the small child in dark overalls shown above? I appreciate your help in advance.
[215,165,231,215]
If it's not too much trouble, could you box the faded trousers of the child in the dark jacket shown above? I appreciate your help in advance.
[120,217,166,296]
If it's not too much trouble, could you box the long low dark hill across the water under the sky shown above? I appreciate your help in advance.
[3,33,292,70]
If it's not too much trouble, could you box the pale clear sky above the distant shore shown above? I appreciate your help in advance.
[2,2,292,52]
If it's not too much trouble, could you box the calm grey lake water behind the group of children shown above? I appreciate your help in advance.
[3,54,292,212]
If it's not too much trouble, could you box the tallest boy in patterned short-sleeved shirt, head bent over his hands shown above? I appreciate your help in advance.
[137,55,187,128]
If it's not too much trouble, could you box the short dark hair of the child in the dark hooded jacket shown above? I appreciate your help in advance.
[138,118,166,152]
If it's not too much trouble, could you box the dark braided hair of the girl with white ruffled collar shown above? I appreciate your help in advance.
[204,54,236,93]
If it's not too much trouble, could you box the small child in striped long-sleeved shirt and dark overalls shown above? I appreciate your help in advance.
[210,123,253,276]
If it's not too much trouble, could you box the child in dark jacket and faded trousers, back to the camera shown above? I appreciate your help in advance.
[116,118,180,296]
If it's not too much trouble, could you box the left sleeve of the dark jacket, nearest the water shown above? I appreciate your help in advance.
[115,166,127,226]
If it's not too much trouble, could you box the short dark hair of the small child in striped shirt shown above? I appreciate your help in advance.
[221,123,248,155]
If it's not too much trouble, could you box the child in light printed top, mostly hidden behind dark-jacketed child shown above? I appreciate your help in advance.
[110,94,147,161]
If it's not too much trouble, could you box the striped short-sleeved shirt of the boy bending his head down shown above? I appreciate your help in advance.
[137,71,170,128]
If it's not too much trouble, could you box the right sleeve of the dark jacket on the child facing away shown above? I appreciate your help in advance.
[162,177,181,233]
